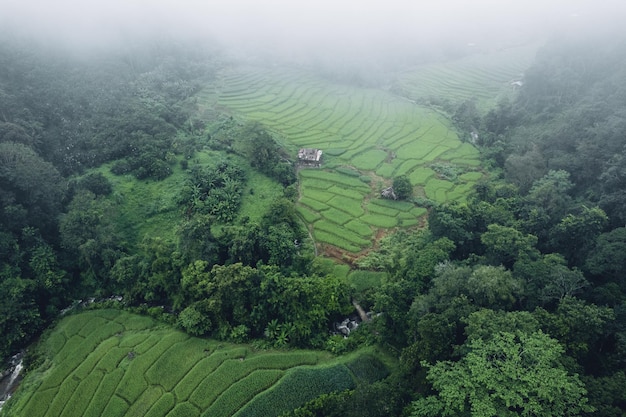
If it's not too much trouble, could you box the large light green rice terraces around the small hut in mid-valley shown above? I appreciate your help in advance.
[199,60,492,253]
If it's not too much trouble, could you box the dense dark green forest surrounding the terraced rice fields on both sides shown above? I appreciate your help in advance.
[0,30,626,417]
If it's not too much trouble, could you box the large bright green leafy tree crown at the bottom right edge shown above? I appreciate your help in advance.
[411,331,593,417]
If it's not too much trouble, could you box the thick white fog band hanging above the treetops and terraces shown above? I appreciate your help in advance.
[0,0,626,65]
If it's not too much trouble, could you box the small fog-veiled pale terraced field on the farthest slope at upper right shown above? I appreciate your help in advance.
[393,44,538,112]
